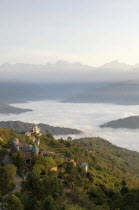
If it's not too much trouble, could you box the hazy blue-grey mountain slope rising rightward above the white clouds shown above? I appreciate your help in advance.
[63,81,139,105]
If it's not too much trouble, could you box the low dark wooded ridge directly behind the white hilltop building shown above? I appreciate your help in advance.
[0,121,82,135]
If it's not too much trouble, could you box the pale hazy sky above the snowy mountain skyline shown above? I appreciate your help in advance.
[0,0,139,65]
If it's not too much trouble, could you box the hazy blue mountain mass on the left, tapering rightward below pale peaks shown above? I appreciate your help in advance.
[0,82,105,104]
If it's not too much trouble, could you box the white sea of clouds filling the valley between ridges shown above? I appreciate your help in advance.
[0,101,139,151]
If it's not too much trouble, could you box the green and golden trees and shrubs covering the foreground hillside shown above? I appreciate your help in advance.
[0,129,139,210]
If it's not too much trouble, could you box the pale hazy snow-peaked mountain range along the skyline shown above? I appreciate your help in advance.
[0,61,139,83]
